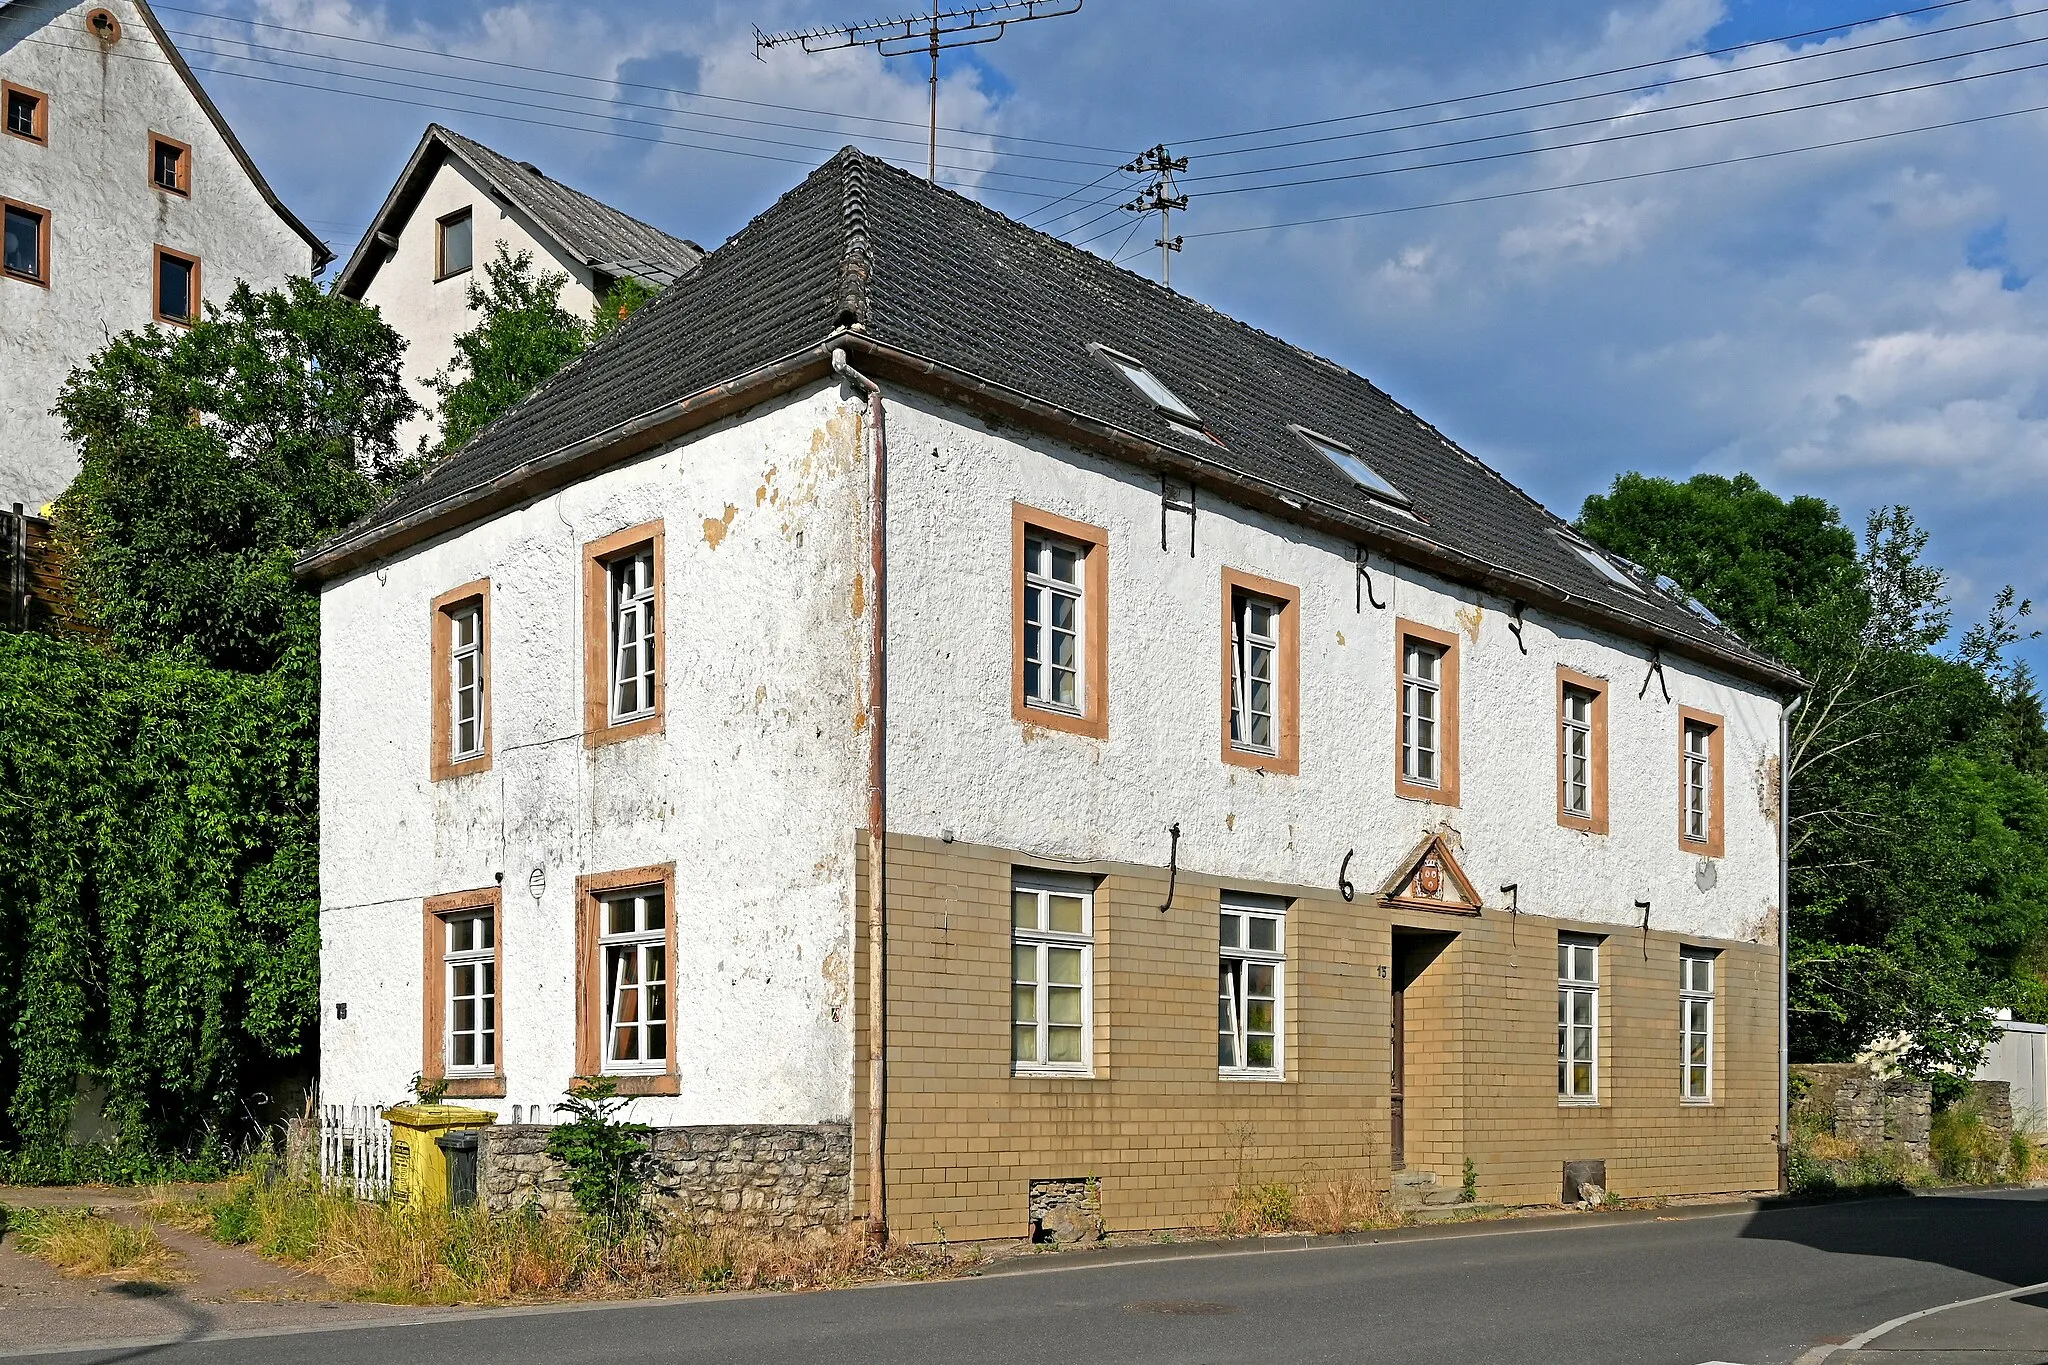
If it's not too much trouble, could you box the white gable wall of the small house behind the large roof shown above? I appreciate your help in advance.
[362,156,596,452]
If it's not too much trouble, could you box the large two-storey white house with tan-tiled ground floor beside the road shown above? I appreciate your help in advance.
[299,149,1802,1238]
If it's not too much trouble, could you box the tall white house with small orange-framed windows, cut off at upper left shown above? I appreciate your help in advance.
[0,0,334,519]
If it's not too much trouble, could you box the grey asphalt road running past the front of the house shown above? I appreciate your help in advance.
[16,1191,2048,1365]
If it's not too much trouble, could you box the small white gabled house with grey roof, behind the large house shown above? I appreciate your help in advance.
[334,123,705,450]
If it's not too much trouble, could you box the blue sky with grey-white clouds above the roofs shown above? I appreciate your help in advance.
[160,0,2048,671]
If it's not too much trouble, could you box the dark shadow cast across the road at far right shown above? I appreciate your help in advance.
[1741,1191,2048,1285]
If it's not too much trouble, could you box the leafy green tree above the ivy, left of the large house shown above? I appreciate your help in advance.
[55,278,416,669]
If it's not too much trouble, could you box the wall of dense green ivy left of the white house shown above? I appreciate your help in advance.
[0,634,319,1154]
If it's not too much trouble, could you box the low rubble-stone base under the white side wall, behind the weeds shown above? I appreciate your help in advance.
[477,1124,852,1232]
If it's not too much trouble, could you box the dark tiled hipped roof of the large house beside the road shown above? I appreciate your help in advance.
[315,147,1792,695]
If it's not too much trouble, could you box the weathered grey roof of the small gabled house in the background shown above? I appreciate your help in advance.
[334,123,705,299]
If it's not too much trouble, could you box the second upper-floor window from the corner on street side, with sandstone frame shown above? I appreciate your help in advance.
[1223,569,1300,774]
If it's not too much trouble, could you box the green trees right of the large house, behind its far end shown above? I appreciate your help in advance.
[1579,475,2048,1070]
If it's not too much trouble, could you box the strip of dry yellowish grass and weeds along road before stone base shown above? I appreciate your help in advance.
[152,1181,983,1304]
